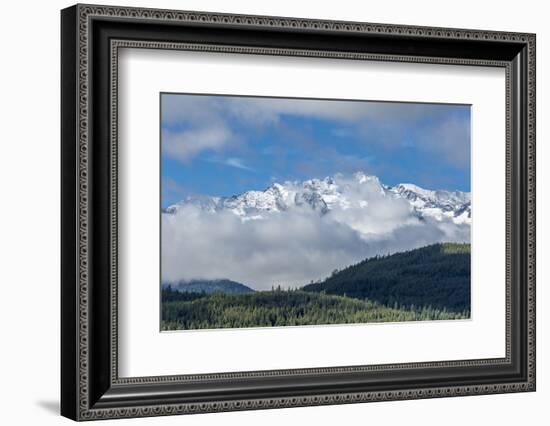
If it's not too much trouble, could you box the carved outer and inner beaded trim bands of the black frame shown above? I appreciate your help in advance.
[61,5,536,420]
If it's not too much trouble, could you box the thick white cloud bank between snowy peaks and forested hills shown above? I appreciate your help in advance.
[161,180,470,289]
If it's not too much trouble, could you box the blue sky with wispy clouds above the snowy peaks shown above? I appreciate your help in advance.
[161,94,470,207]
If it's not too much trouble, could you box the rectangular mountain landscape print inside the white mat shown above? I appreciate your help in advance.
[160,93,472,331]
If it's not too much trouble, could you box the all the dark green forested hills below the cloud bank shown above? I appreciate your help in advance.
[161,244,470,330]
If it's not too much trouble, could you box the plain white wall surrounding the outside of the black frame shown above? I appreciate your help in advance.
[0,0,550,426]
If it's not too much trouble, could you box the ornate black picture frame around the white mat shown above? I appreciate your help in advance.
[61,5,535,420]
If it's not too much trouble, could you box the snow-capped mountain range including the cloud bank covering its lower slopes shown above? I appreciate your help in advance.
[161,173,472,289]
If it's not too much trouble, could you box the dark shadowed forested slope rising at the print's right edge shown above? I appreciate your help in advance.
[303,243,470,312]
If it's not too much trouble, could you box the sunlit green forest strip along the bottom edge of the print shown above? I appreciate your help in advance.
[161,287,468,330]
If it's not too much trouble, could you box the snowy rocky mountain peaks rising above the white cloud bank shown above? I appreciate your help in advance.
[165,172,472,225]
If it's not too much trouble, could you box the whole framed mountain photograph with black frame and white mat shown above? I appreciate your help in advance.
[61,5,535,420]
